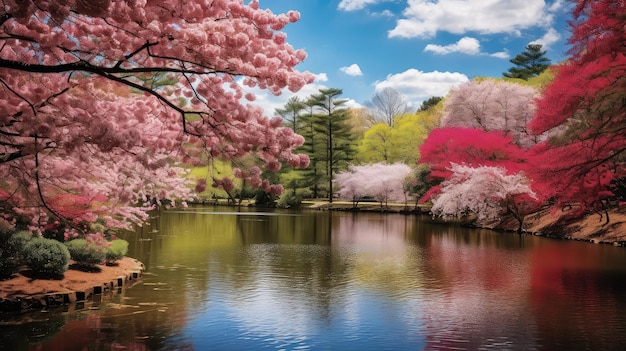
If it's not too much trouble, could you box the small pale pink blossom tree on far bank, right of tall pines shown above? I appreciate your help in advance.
[335,162,411,207]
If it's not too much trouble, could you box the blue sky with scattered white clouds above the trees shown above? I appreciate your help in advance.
[247,0,571,115]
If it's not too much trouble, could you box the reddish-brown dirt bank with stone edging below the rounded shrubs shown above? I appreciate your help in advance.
[0,257,145,312]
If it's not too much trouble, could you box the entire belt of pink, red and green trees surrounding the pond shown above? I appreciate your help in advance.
[0,0,626,273]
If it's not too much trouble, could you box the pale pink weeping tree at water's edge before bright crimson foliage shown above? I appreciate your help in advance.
[431,164,536,232]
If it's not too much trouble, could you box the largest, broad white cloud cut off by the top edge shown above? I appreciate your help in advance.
[388,0,547,38]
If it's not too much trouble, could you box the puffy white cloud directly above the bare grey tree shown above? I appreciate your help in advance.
[374,68,469,107]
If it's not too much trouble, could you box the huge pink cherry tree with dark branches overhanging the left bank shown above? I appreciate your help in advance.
[0,0,313,235]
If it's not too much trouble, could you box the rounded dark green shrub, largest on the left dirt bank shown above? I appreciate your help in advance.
[24,237,70,277]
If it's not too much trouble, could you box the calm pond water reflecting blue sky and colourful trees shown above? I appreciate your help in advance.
[0,208,626,351]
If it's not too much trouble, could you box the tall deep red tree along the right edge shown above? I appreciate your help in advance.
[529,0,626,220]
